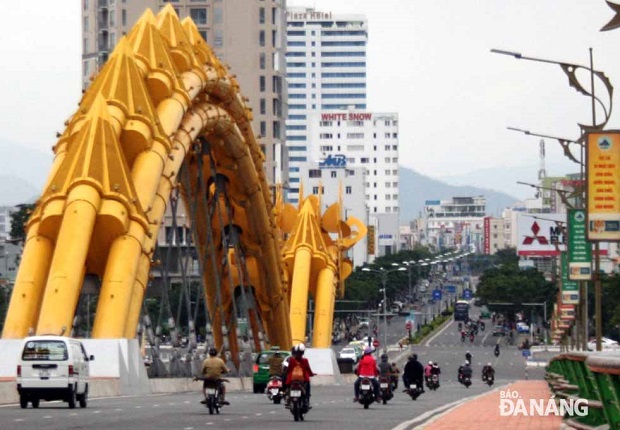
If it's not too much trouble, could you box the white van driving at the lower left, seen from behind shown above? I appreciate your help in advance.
[17,336,95,408]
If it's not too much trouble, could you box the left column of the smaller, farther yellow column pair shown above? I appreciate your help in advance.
[290,246,312,343]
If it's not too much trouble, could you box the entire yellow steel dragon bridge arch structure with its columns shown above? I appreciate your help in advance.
[2,5,366,364]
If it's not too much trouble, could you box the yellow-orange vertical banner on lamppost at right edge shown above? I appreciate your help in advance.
[586,131,620,242]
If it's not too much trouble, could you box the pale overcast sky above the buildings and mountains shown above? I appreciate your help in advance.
[0,0,620,191]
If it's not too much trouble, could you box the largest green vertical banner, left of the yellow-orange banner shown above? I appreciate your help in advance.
[567,209,592,281]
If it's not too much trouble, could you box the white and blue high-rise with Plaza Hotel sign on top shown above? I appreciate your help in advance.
[286,8,368,203]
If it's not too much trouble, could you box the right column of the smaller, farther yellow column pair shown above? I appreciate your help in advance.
[312,266,336,348]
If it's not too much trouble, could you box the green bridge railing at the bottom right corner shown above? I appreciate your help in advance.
[546,352,620,430]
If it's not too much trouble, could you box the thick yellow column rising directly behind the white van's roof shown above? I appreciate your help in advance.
[37,185,100,334]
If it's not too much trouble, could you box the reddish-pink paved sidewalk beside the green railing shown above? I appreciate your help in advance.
[416,381,562,430]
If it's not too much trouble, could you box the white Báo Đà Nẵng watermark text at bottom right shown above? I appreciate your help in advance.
[499,390,588,417]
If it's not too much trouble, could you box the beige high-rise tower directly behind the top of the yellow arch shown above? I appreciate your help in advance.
[82,0,288,183]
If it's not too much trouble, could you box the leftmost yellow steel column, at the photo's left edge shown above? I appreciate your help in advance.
[2,223,53,339]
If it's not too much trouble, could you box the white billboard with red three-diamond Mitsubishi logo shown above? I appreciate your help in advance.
[517,213,566,257]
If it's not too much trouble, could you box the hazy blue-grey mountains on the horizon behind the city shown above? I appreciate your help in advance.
[0,142,519,223]
